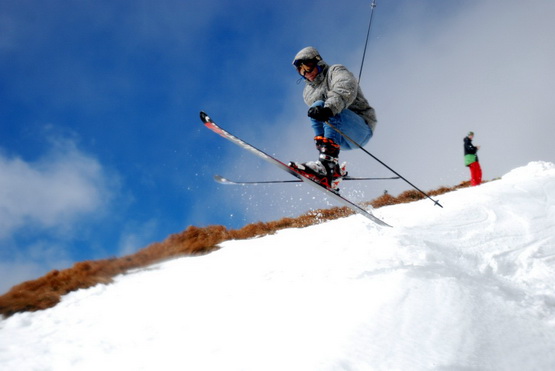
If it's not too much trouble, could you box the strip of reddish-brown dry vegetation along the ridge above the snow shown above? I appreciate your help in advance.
[0,182,476,317]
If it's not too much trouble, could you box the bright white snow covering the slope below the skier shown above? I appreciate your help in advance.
[0,162,555,371]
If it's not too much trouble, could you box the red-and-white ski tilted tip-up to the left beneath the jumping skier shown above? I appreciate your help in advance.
[200,111,391,227]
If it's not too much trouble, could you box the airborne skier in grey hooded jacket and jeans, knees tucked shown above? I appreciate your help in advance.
[289,46,377,191]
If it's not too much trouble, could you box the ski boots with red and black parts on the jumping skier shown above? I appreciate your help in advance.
[289,137,347,193]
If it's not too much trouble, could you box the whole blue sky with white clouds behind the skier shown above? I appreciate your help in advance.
[0,0,555,291]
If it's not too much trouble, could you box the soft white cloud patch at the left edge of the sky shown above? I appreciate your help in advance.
[0,139,115,239]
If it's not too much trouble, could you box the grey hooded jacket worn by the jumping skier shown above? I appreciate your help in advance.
[293,46,377,132]
